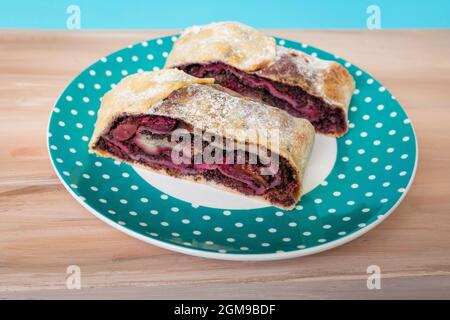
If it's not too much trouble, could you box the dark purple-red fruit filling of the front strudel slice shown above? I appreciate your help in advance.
[96,115,300,206]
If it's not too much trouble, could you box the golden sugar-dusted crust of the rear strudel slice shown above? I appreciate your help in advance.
[166,22,355,136]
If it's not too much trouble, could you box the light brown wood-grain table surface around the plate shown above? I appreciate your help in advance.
[0,30,450,299]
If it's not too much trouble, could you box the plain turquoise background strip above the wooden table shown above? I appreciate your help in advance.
[0,0,450,29]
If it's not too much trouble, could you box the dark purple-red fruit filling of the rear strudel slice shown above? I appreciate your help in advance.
[178,62,347,134]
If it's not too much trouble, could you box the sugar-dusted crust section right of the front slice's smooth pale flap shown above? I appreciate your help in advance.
[147,84,314,172]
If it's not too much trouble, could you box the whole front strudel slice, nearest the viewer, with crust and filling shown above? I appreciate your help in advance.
[89,69,314,209]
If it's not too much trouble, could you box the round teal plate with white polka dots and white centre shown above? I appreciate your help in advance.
[48,36,417,260]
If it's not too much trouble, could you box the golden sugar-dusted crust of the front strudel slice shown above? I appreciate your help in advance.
[90,70,314,208]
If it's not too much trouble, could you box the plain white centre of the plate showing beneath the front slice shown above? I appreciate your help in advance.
[133,135,337,209]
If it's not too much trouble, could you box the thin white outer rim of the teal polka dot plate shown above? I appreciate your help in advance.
[46,35,419,261]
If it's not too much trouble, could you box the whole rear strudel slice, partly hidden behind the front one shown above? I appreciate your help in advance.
[166,22,355,136]
